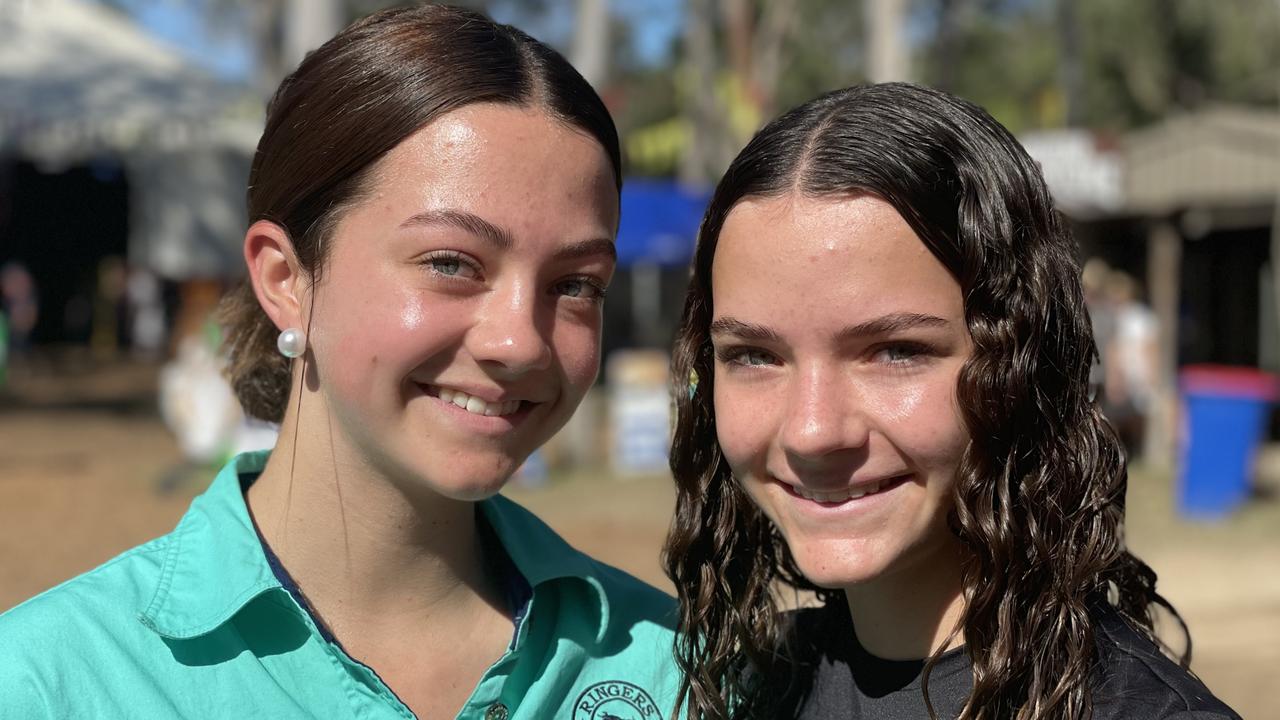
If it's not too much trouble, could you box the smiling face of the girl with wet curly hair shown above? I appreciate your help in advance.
[712,195,972,588]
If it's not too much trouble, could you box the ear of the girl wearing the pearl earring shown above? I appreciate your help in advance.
[244,220,308,331]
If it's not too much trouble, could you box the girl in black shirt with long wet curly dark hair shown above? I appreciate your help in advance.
[666,85,1236,720]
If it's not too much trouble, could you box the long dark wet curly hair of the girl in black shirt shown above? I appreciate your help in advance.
[664,83,1190,719]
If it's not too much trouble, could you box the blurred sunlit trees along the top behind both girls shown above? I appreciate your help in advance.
[100,0,1280,172]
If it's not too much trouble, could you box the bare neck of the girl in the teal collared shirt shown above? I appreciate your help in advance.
[247,407,502,639]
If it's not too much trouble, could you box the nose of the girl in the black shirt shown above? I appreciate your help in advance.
[780,364,869,462]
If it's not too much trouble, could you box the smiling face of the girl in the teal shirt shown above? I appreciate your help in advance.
[310,104,618,500]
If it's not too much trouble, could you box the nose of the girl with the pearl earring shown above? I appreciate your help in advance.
[467,278,552,375]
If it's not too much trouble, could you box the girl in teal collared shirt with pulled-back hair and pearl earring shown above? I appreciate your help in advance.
[0,6,678,720]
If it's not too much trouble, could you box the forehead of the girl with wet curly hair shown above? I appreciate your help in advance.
[712,195,963,324]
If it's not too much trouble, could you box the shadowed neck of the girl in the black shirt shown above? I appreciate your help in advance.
[845,542,964,660]
